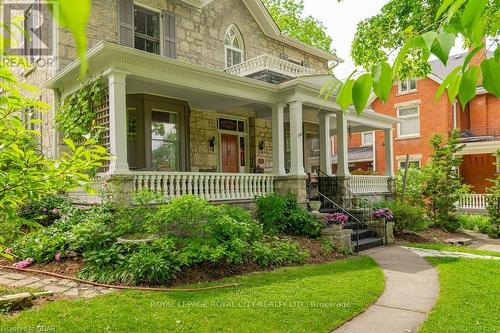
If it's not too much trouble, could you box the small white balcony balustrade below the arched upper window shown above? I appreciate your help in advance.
[225,54,324,77]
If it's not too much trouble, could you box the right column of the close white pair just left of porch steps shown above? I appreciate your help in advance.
[289,101,305,176]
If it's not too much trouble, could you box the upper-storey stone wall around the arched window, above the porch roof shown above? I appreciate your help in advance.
[58,0,327,70]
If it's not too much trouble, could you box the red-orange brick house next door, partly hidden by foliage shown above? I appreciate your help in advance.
[350,53,500,193]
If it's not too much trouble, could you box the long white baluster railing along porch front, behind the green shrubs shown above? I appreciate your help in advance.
[133,172,274,201]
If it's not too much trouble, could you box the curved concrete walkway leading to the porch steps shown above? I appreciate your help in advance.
[333,246,439,333]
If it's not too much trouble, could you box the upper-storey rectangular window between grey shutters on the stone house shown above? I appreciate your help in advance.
[134,6,161,54]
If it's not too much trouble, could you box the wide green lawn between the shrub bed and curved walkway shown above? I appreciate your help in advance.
[0,257,384,332]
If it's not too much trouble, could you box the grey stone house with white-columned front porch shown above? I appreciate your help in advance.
[14,0,395,200]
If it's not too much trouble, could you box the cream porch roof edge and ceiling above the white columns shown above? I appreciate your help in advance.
[45,41,397,129]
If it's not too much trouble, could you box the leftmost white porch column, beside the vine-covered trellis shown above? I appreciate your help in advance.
[104,70,129,174]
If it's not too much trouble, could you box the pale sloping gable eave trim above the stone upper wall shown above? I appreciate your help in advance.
[183,0,344,62]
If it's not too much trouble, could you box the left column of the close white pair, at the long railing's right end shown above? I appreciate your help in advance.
[272,103,286,176]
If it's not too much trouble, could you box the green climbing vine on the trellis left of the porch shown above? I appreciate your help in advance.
[55,79,106,141]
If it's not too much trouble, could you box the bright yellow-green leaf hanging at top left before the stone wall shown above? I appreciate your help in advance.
[50,0,91,76]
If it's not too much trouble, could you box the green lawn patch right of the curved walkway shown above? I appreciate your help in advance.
[420,258,500,333]
